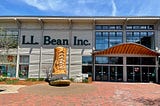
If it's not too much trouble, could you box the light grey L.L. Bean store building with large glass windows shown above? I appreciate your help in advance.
[0,16,160,82]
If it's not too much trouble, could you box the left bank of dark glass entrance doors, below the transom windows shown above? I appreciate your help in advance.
[95,66,123,81]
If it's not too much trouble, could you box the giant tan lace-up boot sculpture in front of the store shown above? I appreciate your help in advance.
[49,47,70,86]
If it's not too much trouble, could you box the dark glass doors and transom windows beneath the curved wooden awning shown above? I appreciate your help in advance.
[95,56,156,82]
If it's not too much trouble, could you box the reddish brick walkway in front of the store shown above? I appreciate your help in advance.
[0,82,160,106]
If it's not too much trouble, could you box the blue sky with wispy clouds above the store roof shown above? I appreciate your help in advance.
[0,0,160,16]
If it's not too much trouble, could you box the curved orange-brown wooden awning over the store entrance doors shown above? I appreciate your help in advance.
[92,43,160,56]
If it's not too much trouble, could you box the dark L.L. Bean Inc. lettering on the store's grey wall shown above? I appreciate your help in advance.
[21,35,91,46]
